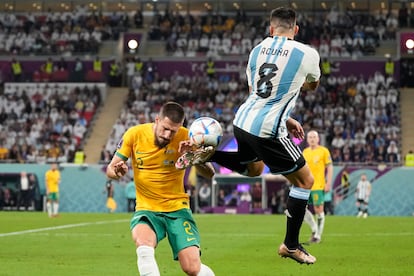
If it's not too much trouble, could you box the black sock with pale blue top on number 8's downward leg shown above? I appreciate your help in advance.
[284,187,310,249]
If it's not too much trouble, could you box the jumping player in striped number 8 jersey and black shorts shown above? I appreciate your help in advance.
[180,7,321,264]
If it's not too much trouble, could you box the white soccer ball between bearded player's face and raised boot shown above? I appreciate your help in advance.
[189,117,223,147]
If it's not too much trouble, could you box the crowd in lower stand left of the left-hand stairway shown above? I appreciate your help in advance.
[0,84,102,164]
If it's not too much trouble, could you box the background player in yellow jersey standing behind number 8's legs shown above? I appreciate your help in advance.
[303,130,333,243]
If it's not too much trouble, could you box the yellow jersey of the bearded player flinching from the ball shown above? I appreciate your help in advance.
[116,123,190,212]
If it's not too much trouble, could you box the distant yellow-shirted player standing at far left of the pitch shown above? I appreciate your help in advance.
[45,163,60,217]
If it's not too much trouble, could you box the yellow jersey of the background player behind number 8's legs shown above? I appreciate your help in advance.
[303,146,332,191]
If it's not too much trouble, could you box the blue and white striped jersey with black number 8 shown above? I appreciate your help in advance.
[233,36,321,138]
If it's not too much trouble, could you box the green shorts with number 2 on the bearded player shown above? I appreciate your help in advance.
[130,209,200,260]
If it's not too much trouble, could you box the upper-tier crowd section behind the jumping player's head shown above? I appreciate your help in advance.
[149,8,407,57]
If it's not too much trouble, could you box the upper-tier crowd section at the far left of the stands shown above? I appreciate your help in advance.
[0,5,130,55]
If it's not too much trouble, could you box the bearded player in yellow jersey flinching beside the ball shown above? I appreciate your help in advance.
[106,102,214,276]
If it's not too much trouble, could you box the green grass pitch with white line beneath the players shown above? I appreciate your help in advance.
[0,212,414,276]
